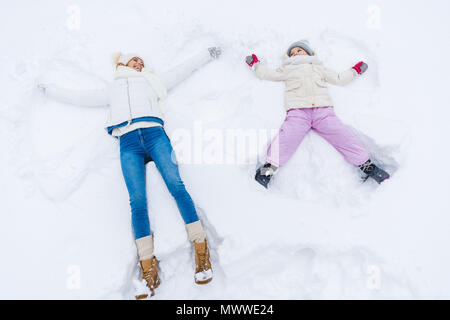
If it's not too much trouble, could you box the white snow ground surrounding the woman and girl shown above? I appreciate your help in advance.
[0,0,450,299]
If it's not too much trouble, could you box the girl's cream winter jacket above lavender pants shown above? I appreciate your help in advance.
[255,55,356,110]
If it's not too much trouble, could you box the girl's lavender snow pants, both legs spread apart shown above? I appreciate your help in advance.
[267,107,369,167]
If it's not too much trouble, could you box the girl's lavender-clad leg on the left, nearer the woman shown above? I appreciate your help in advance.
[267,109,312,167]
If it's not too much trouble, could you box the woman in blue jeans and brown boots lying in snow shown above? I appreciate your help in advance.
[38,47,221,299]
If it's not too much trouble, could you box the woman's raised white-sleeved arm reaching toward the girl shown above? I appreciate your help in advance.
[161,47,222,91]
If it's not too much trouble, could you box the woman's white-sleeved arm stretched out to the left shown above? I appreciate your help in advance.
[38,83,108,107]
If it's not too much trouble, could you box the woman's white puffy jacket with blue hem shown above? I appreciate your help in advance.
[45,50,212,134]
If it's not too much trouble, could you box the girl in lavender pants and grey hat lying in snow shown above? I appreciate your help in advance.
[246,40,389,188]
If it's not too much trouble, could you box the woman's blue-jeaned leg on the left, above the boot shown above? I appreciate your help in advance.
[120,131,150,240]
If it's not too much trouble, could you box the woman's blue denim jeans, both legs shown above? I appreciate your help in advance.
[120,127,199,239]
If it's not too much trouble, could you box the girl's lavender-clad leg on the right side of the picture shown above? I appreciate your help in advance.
[312,107,369,166]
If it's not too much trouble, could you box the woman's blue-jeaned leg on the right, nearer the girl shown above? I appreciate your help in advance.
[144,127,199,224]
